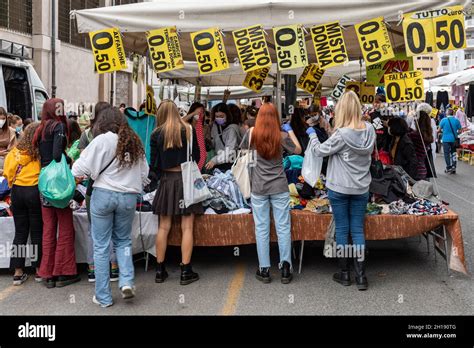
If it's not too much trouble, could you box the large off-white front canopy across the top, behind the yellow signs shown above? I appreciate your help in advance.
[71,0,472,62]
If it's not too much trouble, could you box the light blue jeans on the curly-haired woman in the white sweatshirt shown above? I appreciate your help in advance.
[91,188,137,304]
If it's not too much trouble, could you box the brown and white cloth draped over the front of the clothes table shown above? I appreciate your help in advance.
[0,210,467,274]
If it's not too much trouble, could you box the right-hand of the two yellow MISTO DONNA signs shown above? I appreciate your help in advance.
[311,22,349,69]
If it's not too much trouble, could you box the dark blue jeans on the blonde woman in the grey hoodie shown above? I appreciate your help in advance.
[328,190,369,248]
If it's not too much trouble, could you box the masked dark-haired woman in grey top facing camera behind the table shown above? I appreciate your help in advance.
[206,103,241,172]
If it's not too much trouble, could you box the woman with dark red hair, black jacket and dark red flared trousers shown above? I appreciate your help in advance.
[33,98,80,288]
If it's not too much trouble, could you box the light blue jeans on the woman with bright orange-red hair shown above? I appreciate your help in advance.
[251,192,291,268]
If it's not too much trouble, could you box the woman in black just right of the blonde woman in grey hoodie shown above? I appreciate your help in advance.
[388,117,418,180]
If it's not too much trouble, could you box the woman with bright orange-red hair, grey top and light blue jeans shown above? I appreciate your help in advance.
[242,103,301,284]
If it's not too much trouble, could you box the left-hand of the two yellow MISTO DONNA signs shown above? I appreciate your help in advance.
[232,24,272,72]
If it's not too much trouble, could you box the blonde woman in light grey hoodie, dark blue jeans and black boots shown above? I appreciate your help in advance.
[307,91,376,290]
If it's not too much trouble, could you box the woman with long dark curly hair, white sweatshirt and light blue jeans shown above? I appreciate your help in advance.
[72,107,148,307]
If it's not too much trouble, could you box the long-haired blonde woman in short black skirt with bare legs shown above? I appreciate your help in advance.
[150,100,203,285]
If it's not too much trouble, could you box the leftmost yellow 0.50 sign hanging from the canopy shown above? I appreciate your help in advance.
[89,28,127,74]
